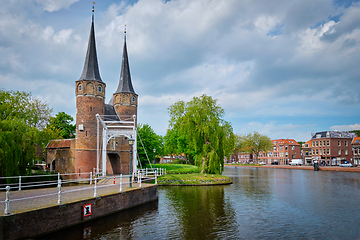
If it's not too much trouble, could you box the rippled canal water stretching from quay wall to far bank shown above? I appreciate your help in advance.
[39,167,360,240]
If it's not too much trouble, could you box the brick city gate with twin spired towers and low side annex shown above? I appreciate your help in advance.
[46,15,138,178]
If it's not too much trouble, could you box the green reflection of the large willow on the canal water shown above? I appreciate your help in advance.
[160,186,237,239]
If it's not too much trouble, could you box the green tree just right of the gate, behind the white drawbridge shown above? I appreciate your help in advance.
[137,123,163,166]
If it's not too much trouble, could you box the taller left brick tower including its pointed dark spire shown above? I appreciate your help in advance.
[74,14,106,177]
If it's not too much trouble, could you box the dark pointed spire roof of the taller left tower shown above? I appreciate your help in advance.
[79,16,103,82]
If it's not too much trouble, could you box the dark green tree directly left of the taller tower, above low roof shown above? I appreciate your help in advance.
[47,112,76,139]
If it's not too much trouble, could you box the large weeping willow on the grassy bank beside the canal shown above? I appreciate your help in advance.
[168,95,235,173]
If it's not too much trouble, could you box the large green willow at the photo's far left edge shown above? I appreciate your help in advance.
[0,89,57,176]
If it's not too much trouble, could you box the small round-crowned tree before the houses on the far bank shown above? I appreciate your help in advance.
[236,131,273,163]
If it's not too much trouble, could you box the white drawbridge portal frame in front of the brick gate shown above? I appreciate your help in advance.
[96,114,137,177]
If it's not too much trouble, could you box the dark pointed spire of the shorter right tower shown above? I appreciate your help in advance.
[115,25,135,93]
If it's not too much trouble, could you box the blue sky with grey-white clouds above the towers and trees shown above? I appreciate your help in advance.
[0,0,360,141]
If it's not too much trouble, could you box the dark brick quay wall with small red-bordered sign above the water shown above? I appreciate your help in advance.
[0,185,158,240]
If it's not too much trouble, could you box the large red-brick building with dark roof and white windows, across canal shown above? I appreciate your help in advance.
[310,131,356,166]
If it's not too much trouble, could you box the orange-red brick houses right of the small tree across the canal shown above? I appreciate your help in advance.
[258,139,301,164]
